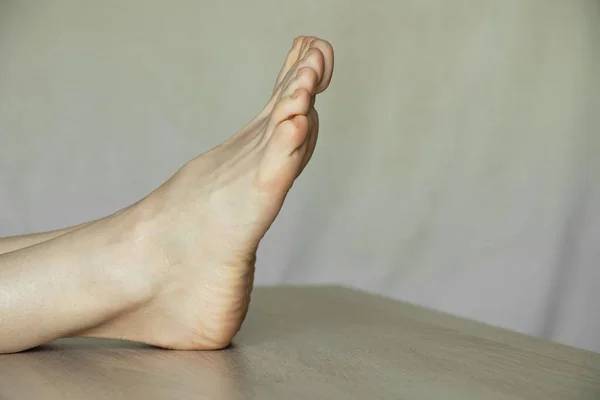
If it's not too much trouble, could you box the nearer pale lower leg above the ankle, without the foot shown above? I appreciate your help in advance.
[0,211,152,353]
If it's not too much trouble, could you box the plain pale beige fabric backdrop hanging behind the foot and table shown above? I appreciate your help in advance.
[0,0,600,351]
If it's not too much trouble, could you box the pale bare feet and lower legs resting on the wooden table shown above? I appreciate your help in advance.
[0,37,333,353]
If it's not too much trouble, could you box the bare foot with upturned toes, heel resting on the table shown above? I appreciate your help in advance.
[80,37,333,350]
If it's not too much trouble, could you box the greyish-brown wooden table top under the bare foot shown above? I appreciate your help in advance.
[0,286,600,400]
